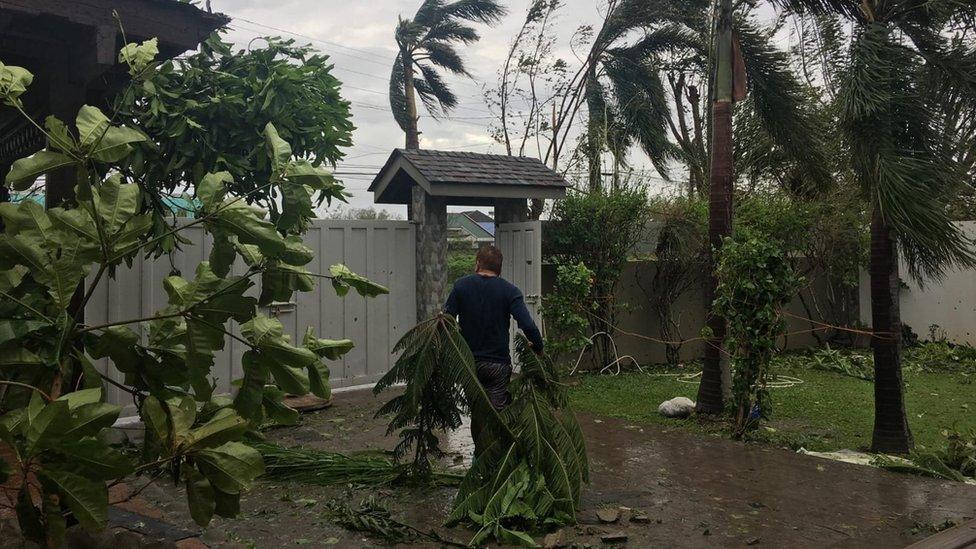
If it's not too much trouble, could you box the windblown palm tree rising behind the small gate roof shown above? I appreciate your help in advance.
[390,0,505,149]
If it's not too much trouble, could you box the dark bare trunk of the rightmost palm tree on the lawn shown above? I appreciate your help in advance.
[868,206,914,454]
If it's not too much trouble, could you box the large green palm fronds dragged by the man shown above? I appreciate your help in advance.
[375,314,589,545]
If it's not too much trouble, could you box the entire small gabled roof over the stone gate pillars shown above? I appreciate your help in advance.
[369,149,569,205]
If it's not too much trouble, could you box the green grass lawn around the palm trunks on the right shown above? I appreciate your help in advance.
[570,368,976,451]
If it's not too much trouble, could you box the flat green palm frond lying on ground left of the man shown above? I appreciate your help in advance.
[249,442,462,487]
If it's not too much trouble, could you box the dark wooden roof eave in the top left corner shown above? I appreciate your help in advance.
[0,0,230,168]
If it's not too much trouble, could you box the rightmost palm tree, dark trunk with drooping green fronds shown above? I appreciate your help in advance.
[776,0,976,453]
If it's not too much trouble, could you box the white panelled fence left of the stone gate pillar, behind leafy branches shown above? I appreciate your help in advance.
[85,220,417,413]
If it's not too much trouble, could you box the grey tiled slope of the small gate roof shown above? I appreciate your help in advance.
[398,149,569,187]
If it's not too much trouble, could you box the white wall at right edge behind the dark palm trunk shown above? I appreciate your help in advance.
[860,221,976,345]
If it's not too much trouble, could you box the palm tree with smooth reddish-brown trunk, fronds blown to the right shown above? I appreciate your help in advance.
[697,4,833,413]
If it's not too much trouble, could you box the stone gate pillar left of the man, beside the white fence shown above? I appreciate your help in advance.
[409,185,447,322]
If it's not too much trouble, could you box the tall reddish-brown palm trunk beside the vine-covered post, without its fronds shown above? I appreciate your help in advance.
[697,0,733,414]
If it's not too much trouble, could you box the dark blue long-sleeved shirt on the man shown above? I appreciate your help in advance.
[444,274,542,364]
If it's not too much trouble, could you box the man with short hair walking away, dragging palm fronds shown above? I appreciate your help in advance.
[444,245,543,455]
